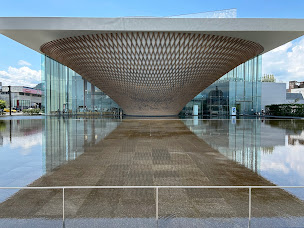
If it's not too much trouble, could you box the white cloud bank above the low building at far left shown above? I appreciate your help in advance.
[0,66,41,87]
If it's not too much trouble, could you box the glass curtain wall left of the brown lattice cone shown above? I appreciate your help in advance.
[42,56,121,115]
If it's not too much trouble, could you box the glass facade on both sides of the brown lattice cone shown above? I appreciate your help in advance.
[42,56,262,115]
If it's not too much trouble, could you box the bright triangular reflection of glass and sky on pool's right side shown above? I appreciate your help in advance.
[183,119,304,199]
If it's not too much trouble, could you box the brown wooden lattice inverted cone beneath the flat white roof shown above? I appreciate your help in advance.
[41,32,263,115]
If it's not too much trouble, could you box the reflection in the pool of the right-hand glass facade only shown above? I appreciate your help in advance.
[184,119,261,172]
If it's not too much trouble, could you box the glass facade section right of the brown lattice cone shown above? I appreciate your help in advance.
[181,56,262,115]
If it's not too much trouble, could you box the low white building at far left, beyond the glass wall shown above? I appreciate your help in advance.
[0,86,42,109]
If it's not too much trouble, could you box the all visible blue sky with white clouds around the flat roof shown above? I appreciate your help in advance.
[0,0,304,87]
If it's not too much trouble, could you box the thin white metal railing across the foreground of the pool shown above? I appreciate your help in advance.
[0,186,304,227]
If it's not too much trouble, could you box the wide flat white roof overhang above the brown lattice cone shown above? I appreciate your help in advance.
[0,17,304,53]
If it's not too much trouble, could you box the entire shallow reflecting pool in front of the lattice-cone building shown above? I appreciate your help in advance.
[0,117,304,227]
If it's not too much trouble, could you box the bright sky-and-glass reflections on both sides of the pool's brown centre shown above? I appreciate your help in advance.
[0,118,304,202]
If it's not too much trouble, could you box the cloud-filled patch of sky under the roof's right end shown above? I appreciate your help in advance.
[262,37,304,82]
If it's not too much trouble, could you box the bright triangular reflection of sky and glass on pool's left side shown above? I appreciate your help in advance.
[0,117,119,202]
